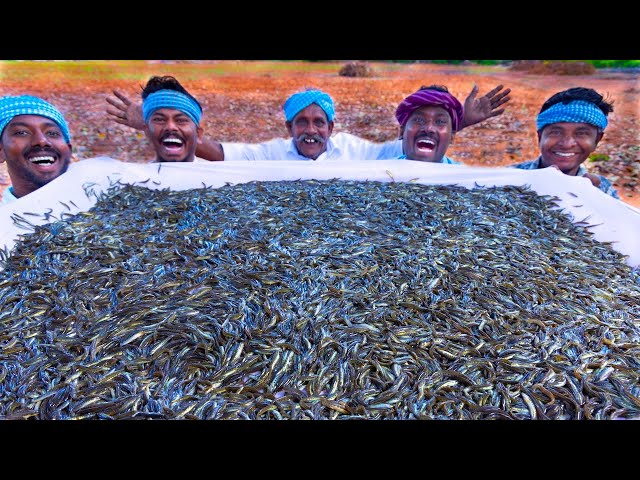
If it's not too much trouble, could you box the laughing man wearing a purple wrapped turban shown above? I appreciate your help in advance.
[396,85,464,165]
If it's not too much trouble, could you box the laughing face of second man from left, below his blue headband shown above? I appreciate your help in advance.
[145,108,202,162]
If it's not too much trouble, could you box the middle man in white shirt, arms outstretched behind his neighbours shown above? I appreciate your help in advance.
[107,85,511,161]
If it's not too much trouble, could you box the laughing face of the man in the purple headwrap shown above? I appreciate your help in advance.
[402,106,455,163]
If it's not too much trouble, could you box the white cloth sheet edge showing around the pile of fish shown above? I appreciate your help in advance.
[0,157,640,267]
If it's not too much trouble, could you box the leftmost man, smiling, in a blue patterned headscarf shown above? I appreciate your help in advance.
[0,95,72,204]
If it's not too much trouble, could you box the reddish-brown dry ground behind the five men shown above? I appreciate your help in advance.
[0,60,640,207]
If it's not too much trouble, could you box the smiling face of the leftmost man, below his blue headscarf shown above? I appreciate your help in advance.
[0,115,71,197]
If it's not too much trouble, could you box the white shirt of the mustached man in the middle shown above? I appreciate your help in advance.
[222,132,402,161]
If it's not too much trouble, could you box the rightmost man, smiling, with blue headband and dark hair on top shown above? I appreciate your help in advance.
[512,87,620,199]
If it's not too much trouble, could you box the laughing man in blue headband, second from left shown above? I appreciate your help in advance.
[142,76,203,162]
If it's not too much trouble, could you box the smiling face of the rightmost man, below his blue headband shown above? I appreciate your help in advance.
[538,122,603,175]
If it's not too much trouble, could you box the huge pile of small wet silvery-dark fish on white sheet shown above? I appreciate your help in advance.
[0,180,640,419]
